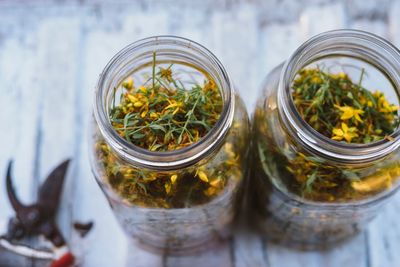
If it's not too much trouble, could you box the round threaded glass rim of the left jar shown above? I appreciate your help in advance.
[94,35,235,170]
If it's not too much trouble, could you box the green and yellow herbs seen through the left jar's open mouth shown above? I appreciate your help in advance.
[110,54,223,151]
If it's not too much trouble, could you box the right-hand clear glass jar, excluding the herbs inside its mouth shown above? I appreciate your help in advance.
[249,30,400,249]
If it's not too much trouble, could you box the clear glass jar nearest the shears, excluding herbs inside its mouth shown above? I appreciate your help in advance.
[90,36,249,254]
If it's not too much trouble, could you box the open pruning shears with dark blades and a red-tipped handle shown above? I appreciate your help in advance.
[0,160,75,267]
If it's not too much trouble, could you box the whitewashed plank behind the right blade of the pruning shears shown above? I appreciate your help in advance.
[35,16,80,266]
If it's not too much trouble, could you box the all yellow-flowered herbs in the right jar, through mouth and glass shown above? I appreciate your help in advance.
[276,67,400,201]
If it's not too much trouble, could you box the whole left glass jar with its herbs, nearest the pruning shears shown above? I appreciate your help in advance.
[90,36,249,253]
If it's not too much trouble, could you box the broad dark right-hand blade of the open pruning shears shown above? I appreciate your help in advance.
[38,159,70,216]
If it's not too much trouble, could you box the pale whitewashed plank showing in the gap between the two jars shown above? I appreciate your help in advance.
[209,5,260,110]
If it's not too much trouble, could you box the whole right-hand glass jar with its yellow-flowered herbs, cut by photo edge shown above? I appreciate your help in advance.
[250,30,400,248]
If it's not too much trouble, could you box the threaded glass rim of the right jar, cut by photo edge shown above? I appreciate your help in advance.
[278,29,400,164]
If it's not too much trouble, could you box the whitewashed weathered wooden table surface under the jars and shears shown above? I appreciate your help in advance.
[0,0,400,267]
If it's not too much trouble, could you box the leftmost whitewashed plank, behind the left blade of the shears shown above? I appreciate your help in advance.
[0,10,40,266]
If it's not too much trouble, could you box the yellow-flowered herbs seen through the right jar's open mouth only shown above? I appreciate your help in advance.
[292,68,400,144]
